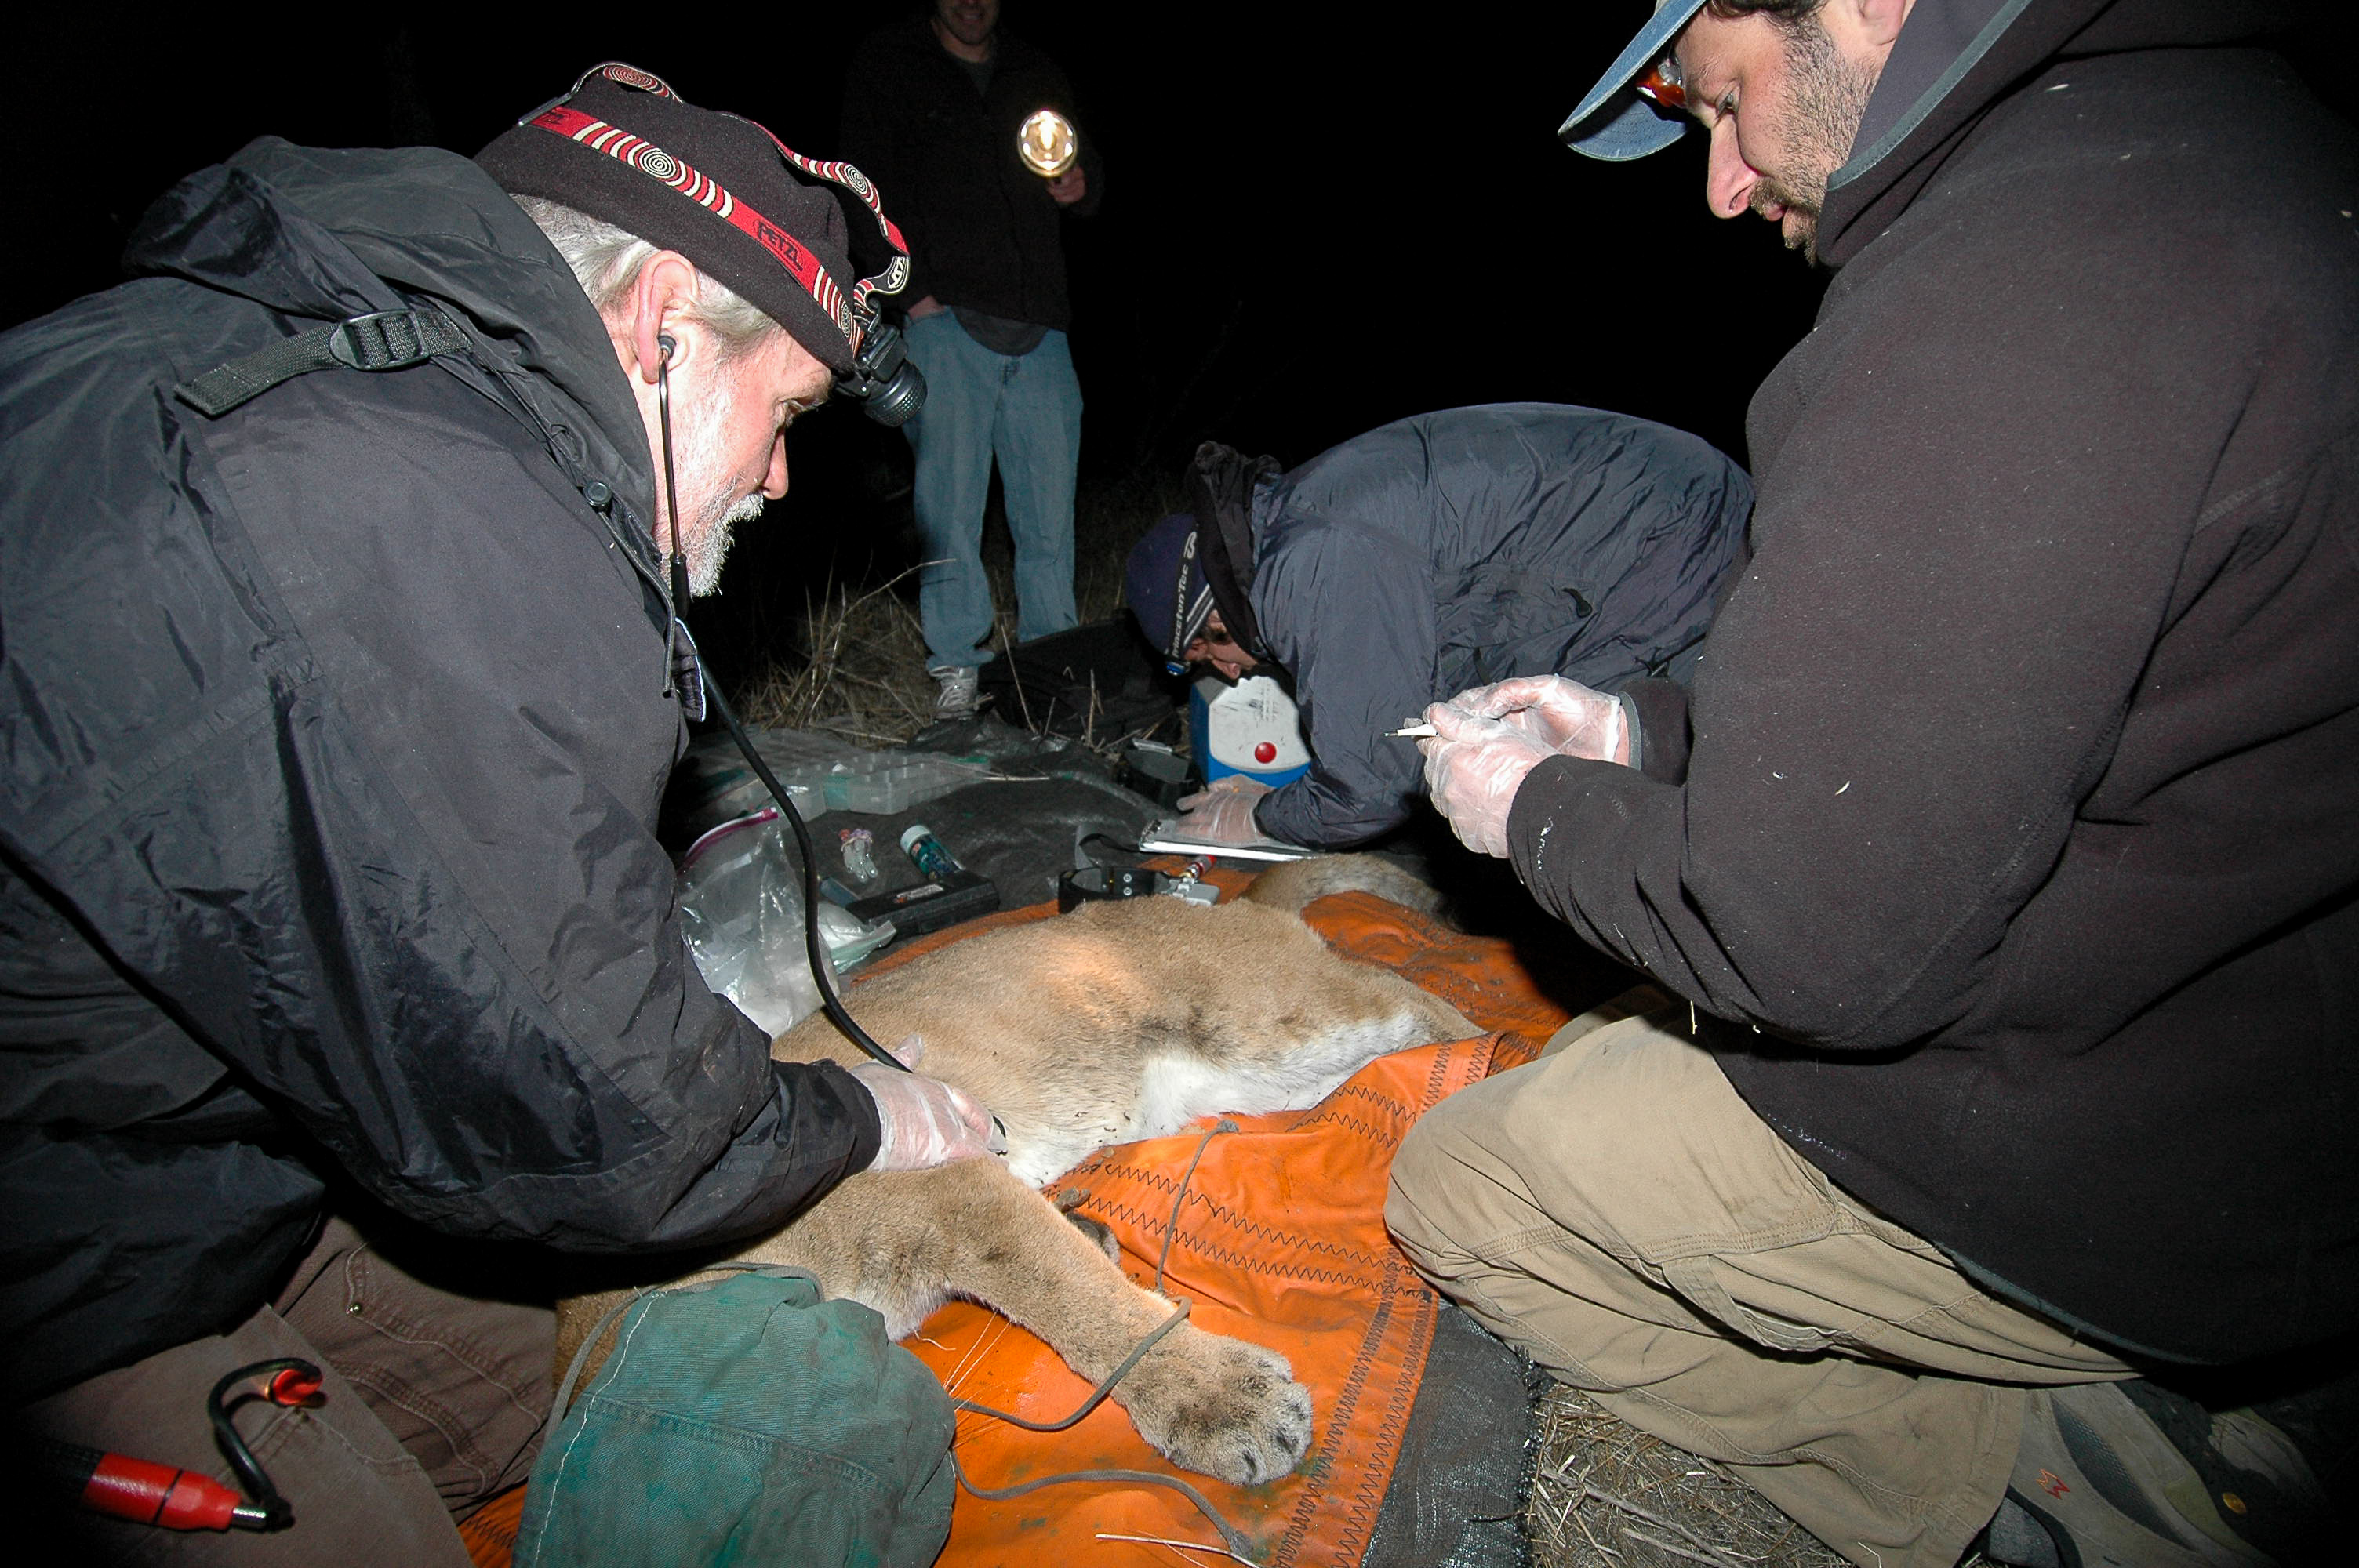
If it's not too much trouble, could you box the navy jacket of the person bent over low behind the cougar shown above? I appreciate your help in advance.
[1250,403,1753,847]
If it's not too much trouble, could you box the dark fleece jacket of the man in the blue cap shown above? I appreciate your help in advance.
[1510,0,2359,1360]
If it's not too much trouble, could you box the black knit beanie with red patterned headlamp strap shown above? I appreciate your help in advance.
[474,64,877,370]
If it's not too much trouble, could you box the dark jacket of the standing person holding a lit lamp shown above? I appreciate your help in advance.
[842,19,1107,330]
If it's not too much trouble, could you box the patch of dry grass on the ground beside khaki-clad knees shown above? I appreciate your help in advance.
[1524,1384,1984,1568]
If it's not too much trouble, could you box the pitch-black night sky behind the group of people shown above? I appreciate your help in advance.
[0,0,2350,679]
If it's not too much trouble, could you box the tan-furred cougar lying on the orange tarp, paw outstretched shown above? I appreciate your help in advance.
[559,856,1477,1483]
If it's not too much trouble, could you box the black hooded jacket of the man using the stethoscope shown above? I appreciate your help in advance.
[0,141,878,1393]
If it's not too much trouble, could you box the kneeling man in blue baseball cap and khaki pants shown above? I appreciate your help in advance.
[1390,0,2359,1568]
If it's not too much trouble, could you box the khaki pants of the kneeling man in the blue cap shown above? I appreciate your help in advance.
[1385,1007,2132,1568]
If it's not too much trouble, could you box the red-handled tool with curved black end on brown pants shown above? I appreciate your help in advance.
[38,1356,321,1530]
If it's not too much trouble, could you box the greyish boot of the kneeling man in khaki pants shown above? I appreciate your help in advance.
[1984,1381,2279,1568]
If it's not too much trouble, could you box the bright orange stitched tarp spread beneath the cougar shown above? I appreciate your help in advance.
[463,870,1568,1568]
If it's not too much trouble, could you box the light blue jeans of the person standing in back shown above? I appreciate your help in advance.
[903,311,1081,670]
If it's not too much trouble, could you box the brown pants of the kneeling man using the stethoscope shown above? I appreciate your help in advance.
[24,1219,557,1568]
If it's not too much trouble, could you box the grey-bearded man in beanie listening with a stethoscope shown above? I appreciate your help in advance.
[0,66,988,1568]
